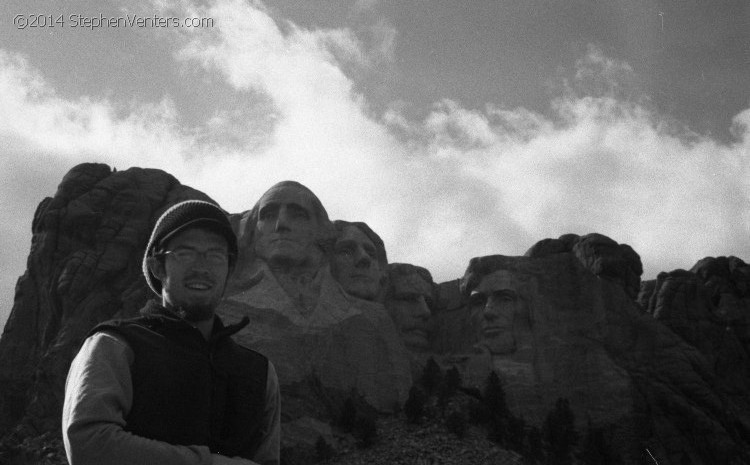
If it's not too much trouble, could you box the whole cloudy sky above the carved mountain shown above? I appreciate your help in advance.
[0,0,750,326]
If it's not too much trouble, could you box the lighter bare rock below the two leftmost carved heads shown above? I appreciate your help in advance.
[217,264,411,417]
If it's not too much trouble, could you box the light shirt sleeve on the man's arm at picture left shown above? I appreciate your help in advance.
[62,332,216,465]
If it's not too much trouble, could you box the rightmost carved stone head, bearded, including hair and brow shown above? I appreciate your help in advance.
[461,255,531,355]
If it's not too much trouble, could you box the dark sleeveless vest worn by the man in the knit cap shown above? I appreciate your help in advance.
[91,302,268,459]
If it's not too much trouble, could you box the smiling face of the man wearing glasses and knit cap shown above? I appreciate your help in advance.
[152,228,229,321]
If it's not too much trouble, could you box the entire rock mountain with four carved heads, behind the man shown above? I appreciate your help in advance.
[0,164,750,464]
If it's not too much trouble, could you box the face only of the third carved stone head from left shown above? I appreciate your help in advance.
[387,273,432,350]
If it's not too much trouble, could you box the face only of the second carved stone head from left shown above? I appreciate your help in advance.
[332,226,383,300]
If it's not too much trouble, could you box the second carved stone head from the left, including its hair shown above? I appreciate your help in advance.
[331,220,388,301]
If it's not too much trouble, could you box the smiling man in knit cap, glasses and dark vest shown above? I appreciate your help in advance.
[62,200,280,465]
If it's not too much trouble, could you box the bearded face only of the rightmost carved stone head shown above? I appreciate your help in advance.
[469,270,523,354]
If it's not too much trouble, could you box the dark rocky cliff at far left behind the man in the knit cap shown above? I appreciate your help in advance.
[0,164,208,442]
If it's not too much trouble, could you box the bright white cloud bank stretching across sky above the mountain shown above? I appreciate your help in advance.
[0,0,750,330]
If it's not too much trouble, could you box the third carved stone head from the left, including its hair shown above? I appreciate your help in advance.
[385,263,434,352]
